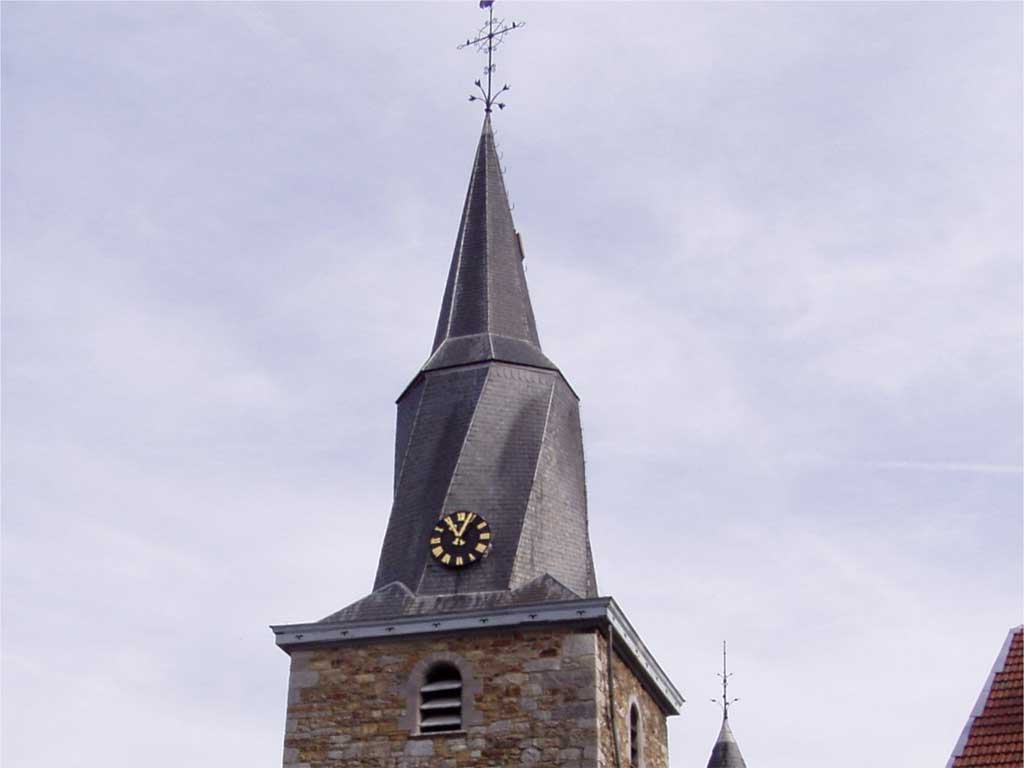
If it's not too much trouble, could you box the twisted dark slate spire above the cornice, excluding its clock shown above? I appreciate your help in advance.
[350,116,597,621]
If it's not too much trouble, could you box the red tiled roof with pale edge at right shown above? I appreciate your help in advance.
[947,627,1024,768]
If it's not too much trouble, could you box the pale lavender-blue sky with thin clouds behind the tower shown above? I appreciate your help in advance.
[2,2,1024,768]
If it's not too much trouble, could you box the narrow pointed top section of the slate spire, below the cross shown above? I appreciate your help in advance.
[423,115,556,371]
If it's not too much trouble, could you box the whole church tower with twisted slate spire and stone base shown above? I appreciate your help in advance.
[272,3,683,768]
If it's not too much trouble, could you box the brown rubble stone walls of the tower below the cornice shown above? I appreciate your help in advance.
[284,628,668,768]
